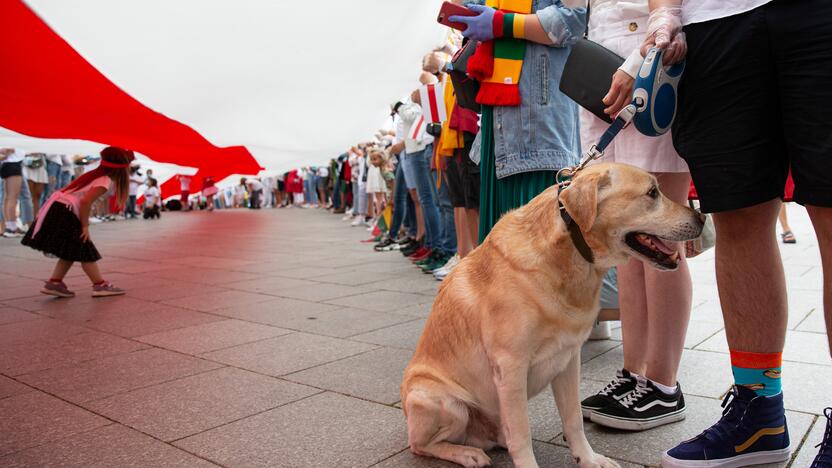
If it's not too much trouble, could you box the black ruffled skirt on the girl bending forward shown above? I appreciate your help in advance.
[21,202,101,263]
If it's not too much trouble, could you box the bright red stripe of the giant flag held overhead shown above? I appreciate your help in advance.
[0,0,261,197]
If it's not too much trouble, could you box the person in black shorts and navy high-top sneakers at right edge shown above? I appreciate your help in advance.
[641,0,832,468]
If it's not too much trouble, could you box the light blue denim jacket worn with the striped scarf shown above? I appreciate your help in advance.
[471,0,586,179]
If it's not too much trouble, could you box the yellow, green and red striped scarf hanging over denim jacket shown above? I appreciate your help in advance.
[468,0,532,106]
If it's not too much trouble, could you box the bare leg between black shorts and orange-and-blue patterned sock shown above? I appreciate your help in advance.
[713,199,788,353]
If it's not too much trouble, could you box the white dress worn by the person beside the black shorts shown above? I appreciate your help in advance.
[580,0,688,172]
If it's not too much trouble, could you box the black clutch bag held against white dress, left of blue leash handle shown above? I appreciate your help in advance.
[560,38,624,123]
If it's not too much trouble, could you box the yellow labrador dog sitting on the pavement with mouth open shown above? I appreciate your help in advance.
[401,164,704,468]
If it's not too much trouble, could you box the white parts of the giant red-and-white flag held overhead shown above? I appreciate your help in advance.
[0,0,447,176]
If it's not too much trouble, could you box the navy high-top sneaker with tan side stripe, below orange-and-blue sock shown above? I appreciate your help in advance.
[662,386,789,468]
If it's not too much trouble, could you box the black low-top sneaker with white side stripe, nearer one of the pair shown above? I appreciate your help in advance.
[590,377,685,431]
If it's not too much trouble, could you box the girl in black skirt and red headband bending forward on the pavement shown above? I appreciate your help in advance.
[22,146,133,297]
